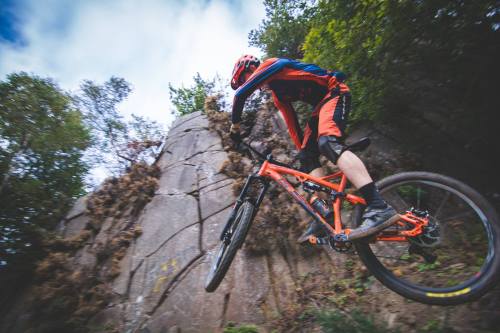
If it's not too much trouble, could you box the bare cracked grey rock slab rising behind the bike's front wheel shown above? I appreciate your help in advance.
[101,113,329,332]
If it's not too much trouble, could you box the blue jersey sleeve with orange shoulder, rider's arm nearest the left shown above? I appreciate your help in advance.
[231,58,290,124]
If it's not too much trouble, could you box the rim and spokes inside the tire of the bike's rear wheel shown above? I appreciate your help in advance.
[368,180,494,291]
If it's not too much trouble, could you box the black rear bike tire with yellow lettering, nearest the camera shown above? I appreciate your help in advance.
[353,172,500,305]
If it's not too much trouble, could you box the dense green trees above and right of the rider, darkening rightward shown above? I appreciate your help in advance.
[249,0,500,157]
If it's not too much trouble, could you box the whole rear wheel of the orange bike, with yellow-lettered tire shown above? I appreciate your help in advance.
[354,172,500,305]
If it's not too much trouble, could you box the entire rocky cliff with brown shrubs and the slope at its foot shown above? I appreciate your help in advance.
[1,104,500,333]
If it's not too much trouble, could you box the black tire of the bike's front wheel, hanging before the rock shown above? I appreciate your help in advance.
[205,201,254,292]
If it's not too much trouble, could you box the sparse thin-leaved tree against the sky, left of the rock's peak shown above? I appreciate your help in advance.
[74,77,164,174]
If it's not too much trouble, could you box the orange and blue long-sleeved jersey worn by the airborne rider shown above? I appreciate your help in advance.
[231,58,349,148]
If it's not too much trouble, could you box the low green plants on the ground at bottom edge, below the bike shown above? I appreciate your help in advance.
[316,310,397,333]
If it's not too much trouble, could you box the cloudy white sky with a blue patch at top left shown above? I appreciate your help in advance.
[0,0,265,125]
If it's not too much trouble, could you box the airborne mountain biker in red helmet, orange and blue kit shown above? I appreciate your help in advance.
[230,55,397,242]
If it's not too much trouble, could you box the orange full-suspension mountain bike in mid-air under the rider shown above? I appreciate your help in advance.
[205,138,500,305]
